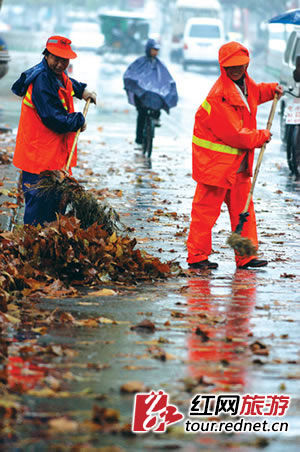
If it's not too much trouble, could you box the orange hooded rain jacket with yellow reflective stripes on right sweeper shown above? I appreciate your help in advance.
[193,67,277,188]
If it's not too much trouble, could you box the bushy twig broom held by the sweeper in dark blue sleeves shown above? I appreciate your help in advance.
[34,98,126,235]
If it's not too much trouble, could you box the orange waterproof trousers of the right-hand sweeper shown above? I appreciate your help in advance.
[187,173,258,267]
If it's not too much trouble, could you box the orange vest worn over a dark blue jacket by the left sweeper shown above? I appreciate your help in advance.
[13,73,77,174]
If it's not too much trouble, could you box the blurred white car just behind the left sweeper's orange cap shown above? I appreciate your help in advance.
[69,21,104,52]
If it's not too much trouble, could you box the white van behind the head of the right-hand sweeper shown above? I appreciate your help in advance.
[183,18,225,70]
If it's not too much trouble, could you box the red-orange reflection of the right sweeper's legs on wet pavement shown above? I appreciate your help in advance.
[187,270,256,393]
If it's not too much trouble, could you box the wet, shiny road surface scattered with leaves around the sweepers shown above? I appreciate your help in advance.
[0,47,300,452]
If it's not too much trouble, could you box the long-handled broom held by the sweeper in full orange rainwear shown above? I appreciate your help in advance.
[227,94,278,256]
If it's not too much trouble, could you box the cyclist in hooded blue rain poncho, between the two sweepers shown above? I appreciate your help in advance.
[123,39,178,144]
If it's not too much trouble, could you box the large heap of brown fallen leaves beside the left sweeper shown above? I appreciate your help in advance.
[0,215,181,311]
